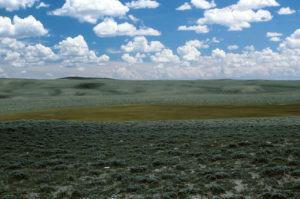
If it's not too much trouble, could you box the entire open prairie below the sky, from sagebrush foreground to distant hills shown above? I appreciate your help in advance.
[0,78,300,199]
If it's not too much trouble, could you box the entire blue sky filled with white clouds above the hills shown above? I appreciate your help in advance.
[0,0,300,80]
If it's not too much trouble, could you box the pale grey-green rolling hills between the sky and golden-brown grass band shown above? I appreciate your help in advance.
[0,78,300,113]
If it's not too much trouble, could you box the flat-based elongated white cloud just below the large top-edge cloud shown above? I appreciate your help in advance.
[93,18,161,37]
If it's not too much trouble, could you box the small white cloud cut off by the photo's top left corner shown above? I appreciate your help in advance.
[0,0,39,11]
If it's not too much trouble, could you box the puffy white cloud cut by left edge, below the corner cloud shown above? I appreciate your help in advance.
[0,15,48,38]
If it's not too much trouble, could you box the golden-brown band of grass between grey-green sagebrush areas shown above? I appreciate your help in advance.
[0,104,300,121]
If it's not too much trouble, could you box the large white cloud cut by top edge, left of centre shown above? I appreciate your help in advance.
[51,0,129,23]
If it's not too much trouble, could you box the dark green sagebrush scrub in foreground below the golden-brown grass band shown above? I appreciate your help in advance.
[0,117,300,199]
